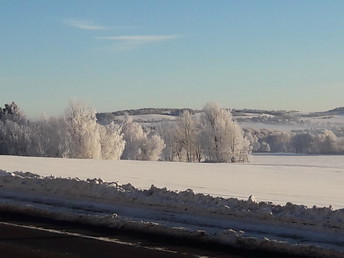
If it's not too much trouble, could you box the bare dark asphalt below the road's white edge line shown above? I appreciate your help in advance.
[0,221,191,258]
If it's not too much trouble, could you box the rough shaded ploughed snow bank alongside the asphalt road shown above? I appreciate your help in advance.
[0,170,344,257]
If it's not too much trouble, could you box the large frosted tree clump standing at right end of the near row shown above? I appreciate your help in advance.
[159,103,251,162]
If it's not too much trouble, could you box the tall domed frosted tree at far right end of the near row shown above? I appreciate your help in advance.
[200,103,250,162]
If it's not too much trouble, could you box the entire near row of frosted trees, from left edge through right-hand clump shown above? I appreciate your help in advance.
[0,103,250,162]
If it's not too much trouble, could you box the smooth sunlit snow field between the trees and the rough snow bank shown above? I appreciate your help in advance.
[0,155,344,208]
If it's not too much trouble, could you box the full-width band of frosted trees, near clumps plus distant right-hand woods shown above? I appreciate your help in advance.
[0,102,344,162]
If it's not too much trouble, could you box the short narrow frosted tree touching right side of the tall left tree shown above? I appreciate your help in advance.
[99,122,125,160]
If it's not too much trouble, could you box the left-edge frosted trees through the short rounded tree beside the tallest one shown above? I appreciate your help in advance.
[0,103,125,159]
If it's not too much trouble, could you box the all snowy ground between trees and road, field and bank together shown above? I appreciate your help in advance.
[0,155,344,257]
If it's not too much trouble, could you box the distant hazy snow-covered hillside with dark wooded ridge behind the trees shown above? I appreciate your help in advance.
[97,108,344,131]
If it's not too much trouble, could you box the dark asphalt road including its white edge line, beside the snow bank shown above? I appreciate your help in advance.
[0,213,306,258]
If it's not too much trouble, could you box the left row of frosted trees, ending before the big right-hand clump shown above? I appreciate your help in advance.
[0,103,164,160]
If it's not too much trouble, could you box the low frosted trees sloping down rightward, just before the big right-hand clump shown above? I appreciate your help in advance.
[122,116,165,160]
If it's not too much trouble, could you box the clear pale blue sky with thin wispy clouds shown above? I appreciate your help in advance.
[0,0,344,117]
